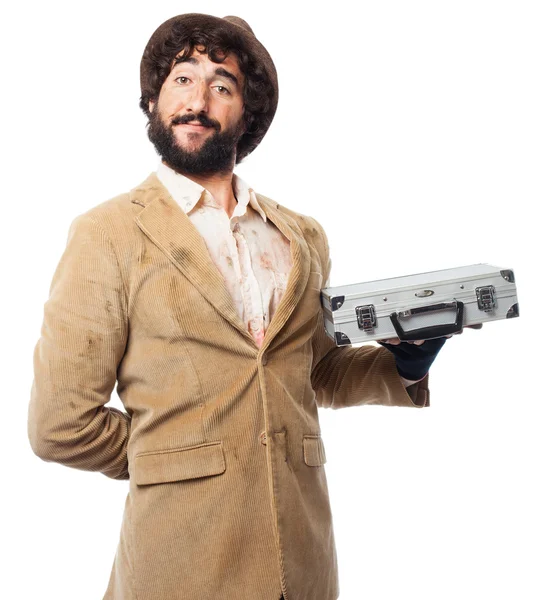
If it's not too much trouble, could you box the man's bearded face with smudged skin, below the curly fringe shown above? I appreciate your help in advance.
[147,50,244,175]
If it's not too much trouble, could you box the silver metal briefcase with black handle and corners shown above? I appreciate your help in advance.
[321,263,519,346]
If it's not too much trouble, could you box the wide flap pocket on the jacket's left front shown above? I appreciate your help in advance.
[134,441,226,485]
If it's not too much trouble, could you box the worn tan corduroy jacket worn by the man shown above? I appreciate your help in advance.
[28,172,429,600]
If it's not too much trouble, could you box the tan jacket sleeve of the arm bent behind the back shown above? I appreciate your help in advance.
[28,213,131,479]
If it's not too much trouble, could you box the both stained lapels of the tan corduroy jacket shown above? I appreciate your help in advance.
[130,172,310,350]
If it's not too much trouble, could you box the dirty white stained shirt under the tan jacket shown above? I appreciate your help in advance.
[157,161,292,347]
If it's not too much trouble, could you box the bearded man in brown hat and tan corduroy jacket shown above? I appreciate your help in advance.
[28,14,468,600]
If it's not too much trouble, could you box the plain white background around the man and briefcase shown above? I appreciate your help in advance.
[0,0,537,600]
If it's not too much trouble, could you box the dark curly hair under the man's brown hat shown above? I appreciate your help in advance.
[139,23,274,164]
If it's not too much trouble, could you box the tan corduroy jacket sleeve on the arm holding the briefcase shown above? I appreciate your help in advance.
[311,217,429,409]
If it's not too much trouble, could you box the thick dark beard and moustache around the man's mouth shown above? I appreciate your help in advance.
[147,102,243,176]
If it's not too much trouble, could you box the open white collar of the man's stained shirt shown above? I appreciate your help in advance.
[157,161,267,223]
